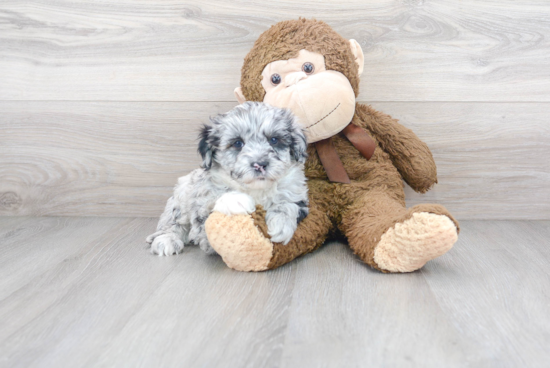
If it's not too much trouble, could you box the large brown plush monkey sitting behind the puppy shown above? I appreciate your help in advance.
[206,19,459,272]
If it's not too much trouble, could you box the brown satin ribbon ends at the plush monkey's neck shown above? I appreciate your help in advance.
[315,123,376,184]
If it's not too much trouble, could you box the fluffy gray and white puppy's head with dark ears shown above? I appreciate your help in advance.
[199,102,307,188]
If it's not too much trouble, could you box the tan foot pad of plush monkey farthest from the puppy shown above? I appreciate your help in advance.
[374,212,458,272]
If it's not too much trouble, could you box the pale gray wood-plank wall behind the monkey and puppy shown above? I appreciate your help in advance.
[0,0,550,219]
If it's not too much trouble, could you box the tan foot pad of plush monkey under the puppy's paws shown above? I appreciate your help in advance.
[204,212,273,271]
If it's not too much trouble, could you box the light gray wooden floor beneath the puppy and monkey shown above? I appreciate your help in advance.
[0,217,550,367]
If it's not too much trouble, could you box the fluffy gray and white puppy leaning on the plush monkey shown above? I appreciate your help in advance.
[147,102,308,255]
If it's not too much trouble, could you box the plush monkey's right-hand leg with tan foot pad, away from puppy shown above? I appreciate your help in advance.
[340,189,459,272]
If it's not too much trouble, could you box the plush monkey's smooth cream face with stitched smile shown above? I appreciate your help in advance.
[262,50,355,143]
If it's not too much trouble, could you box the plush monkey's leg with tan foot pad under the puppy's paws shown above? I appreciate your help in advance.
[205,187,332,271]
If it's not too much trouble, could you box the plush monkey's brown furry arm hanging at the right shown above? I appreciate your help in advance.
[353,104,437,193]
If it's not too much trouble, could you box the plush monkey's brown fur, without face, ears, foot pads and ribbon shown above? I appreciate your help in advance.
[205,19,459,272]
